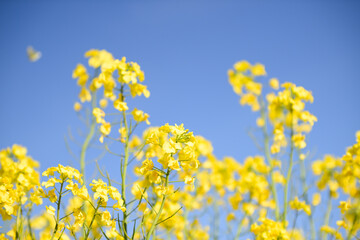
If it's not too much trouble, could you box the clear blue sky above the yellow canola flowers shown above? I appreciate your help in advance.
[0,1,360,236]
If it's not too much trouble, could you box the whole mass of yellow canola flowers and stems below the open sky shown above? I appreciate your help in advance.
[0,52,360,240]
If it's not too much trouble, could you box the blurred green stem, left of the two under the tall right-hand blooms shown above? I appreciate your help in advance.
[259,97,280,221]
